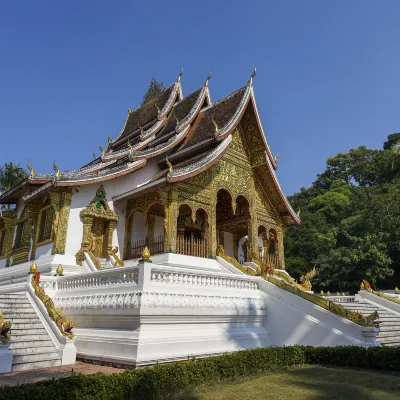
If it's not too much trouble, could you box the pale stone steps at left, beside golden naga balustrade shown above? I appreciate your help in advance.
[0,293,61,371]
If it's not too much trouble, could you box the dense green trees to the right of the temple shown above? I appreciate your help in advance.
[285,134,400,291]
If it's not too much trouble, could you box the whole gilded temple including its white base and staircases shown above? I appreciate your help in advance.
[0,71,386,373]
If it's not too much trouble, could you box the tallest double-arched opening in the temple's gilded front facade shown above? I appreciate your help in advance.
[216,189,251,264]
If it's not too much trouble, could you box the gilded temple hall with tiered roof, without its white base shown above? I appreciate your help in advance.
[0,74,299,270]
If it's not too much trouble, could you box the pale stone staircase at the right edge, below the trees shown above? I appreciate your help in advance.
[332,298,400,347]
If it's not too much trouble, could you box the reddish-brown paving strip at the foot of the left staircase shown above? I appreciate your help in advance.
[0,362,126,387]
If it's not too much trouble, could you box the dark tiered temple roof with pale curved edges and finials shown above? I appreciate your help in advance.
[0,74,299,224]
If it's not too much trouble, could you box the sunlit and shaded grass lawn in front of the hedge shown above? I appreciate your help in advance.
[179,366,400,400]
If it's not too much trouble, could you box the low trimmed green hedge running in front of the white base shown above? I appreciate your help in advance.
[0,346,400,400]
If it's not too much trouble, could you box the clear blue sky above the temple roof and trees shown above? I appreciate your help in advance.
[0,0,400,195]
